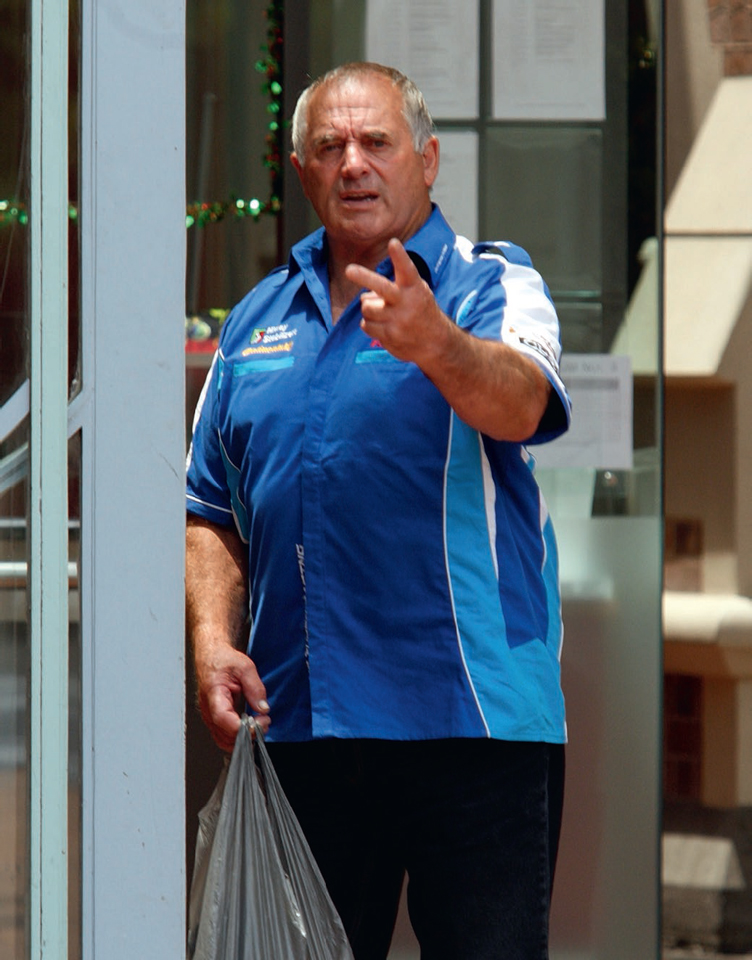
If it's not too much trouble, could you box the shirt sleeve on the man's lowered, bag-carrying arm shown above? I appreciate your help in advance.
[186,351,234,527]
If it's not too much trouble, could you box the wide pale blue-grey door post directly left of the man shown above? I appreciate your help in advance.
[77,0,185,960]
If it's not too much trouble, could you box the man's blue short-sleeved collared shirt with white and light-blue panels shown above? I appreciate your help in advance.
[188,208,570,742]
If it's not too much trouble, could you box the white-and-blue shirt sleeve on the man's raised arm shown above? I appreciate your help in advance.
[463,242,572,444]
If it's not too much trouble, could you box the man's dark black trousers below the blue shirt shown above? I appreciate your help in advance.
[269,739,564,960]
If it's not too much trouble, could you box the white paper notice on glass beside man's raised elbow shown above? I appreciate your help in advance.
[530,353,633,470]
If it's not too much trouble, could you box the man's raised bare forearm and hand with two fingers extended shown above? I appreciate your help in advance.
[346,240,551,442]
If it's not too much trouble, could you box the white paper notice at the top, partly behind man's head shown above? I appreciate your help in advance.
[366,0,478,120]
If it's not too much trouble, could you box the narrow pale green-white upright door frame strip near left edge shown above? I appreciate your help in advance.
[27,0,68,960]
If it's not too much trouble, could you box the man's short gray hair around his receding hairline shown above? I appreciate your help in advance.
[292,61,435,165]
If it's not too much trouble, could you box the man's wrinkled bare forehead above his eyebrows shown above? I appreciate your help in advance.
[308,74,408,139]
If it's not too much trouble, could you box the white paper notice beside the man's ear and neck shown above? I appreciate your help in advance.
[432,130,478,243]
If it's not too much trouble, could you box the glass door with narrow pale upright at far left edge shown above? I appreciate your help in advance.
[0,0,81,960]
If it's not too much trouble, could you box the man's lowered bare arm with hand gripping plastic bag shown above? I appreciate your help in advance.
[185,514,270,750]
